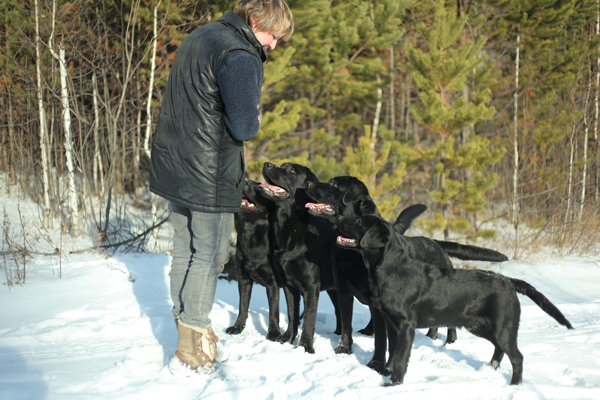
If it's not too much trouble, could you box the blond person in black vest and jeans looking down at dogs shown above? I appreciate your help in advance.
[150,0,294,369]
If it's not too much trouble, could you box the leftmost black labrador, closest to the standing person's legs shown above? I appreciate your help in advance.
[225,180,298,341]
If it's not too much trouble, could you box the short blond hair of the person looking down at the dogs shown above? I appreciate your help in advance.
[233,0,294,40]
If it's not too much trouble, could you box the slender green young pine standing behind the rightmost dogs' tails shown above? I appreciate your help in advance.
[405,0,504,238]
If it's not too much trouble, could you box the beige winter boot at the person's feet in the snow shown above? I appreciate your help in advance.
[175,321,219,369]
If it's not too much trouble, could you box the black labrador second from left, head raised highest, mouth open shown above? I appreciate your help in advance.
[260,162,342,353]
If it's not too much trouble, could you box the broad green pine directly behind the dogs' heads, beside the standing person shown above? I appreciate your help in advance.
[251,0,407,179]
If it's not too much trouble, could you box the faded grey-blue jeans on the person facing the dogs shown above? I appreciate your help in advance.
[171,203,233,328]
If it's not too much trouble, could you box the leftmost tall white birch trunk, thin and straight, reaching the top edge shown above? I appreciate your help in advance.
[34,0,51,229]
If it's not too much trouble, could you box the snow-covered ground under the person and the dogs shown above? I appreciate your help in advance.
[0,186,600,400]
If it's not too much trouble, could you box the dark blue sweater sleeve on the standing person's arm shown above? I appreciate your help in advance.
[217,50,262,142]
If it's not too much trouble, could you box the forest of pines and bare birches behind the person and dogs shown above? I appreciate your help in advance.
[0,0,600,257]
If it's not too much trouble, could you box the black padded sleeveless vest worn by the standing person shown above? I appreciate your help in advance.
[150,12,266,212]
